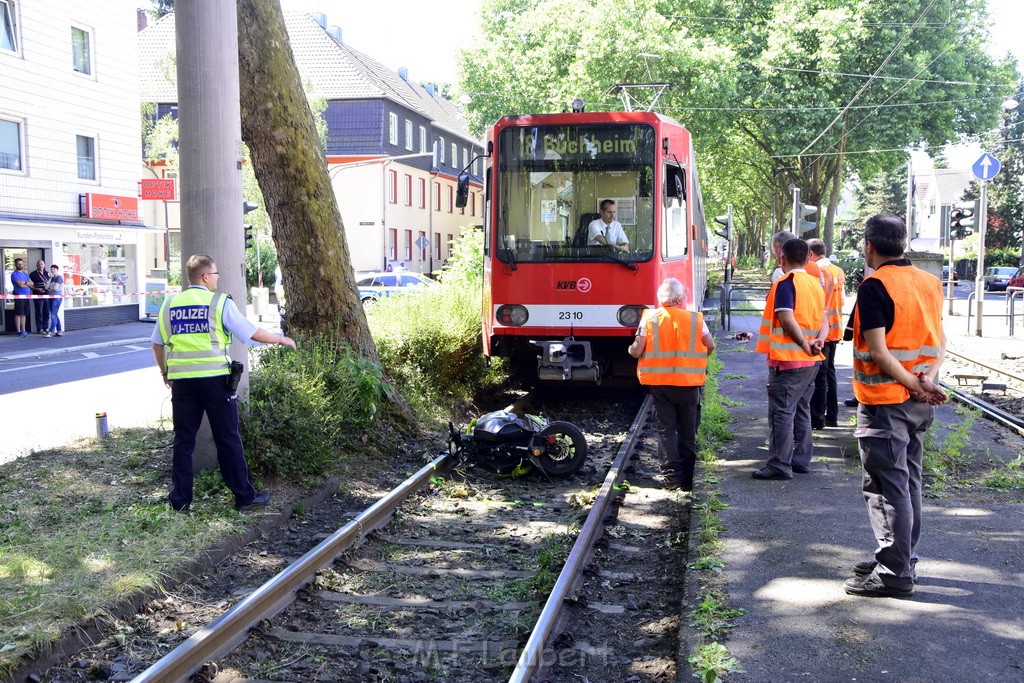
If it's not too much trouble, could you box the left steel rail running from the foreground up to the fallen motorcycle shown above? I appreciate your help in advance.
[126,454,454,683]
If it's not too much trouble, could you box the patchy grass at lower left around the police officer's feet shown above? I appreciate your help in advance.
[0,429,244,676]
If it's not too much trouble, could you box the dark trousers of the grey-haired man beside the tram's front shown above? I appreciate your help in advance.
[650,385,701,490]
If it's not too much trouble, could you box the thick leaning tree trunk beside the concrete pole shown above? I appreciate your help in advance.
[238,0,378,360]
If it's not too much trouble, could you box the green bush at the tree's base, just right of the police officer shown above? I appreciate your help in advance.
[242,339,389,480]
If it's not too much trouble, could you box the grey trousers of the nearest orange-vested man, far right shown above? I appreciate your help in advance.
[855,398,935,589]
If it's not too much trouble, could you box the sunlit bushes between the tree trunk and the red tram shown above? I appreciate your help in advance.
[367,228,499,411]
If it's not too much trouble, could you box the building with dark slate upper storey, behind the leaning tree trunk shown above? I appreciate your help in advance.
[138,12,483,272]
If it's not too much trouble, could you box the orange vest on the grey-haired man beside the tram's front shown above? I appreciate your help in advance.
[637,306,708,386]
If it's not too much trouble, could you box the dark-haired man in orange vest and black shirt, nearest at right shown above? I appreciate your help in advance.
[845,213,946,598]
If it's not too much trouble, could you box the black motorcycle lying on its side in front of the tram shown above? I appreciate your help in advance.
[449,411,587,477]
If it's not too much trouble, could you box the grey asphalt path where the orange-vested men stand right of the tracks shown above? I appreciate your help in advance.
[704,316,1024,681]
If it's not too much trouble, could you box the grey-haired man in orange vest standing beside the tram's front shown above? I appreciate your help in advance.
[629,278,715,490]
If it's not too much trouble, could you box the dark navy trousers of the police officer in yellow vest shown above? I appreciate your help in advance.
[169,376,256,510]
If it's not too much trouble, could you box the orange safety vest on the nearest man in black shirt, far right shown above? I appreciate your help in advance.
[853,265,942,405]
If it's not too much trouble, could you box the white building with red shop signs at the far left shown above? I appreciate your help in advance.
[0,0,162,334]
